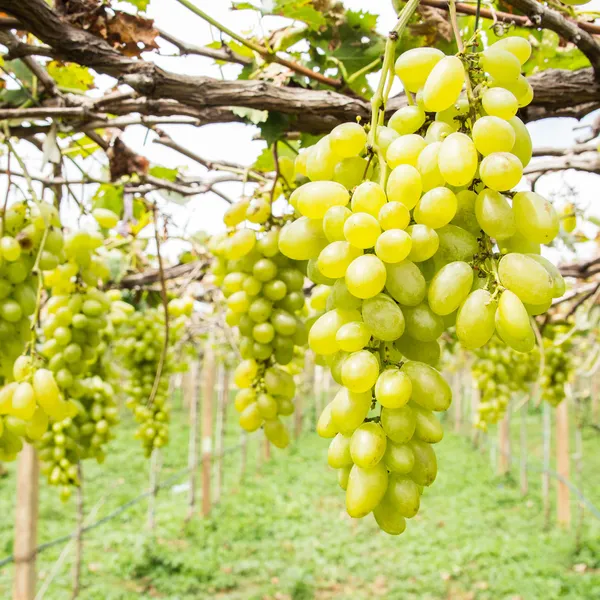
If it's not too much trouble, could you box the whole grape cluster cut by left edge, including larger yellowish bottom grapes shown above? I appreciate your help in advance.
[0,202,70,461]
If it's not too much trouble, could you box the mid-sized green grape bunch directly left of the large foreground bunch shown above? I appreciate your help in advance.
[211,213,307,448]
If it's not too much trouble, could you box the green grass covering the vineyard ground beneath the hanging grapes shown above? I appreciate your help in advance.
[0,398,600,600]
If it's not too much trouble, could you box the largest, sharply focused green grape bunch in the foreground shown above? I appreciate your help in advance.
[279,38,564,534]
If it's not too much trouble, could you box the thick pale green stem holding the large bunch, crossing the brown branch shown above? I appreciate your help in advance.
[368,0,420,187]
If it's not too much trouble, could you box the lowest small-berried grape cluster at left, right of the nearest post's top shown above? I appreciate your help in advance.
[38,375,119,501]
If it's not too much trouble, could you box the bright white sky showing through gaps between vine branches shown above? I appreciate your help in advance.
[1,0,600,260]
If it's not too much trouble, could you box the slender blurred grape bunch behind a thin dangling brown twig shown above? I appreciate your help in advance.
[115,301,192,456]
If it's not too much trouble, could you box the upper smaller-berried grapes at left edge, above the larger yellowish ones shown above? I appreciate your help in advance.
[0,202,63,381]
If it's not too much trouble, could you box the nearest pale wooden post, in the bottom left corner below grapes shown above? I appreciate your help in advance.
[13,444,39,600]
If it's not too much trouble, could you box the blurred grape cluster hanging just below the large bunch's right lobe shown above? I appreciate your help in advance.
[471,337,539,431]
